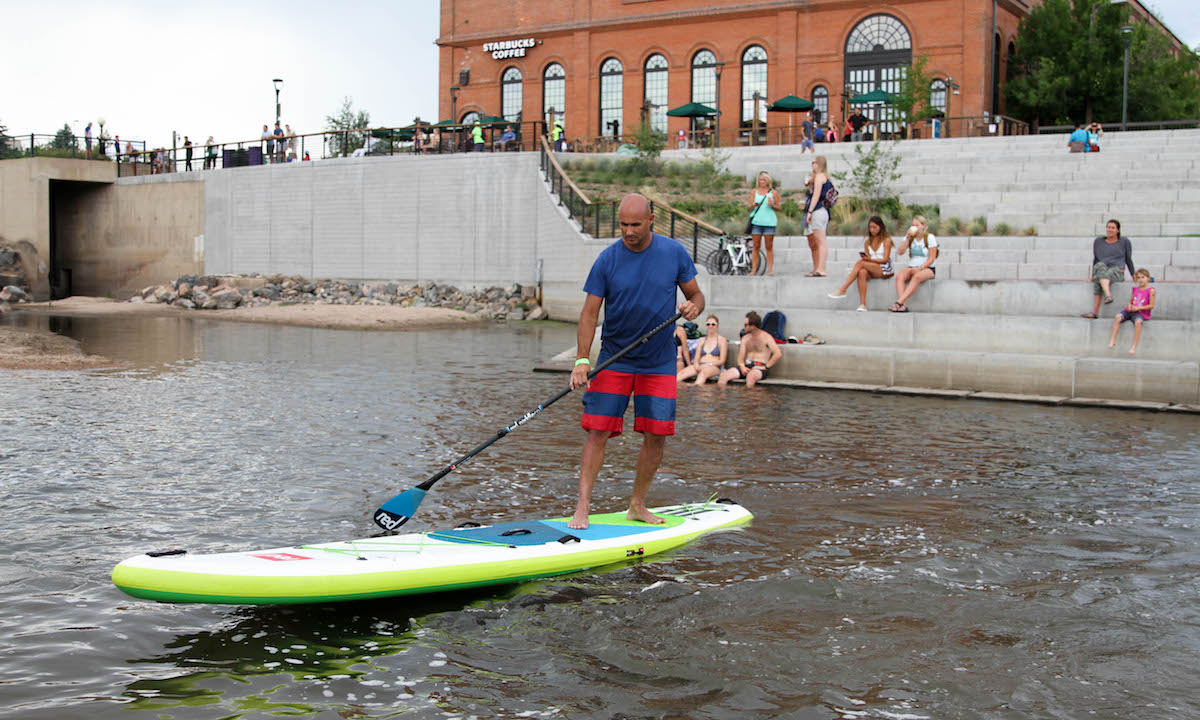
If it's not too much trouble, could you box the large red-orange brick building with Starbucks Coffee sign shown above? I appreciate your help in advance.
[437,0,1030,143]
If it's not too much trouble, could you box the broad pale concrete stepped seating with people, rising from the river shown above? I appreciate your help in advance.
[662,130,1200,403]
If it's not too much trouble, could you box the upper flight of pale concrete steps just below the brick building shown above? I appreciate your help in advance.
[664,130,1200,238]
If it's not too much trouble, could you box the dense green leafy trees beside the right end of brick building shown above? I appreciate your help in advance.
[1004,0,1200,124]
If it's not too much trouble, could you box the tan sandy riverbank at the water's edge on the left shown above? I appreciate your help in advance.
[0,298,486,370]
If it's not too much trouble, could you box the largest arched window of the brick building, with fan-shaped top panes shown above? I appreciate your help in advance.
[845,13,912,132]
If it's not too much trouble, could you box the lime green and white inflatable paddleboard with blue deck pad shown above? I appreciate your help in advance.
[113,500,752,605]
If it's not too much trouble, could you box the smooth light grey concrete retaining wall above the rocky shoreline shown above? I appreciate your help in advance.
[204,154,607,316]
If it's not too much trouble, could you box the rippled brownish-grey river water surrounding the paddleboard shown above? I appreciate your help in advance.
[0,316,1200,720]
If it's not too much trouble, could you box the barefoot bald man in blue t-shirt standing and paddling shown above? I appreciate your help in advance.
[568,193,704,529]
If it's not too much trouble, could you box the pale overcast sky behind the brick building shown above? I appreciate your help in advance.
[0,0,1200,146]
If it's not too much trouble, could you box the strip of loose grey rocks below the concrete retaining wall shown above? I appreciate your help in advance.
[128,275,548,322]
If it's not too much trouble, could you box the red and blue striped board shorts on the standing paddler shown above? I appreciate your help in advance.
[580,370,678,437]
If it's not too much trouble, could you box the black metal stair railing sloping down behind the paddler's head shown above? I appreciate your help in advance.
[540,140,724,264]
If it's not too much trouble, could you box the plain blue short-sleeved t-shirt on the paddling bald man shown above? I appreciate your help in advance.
[583,233,696,374]
